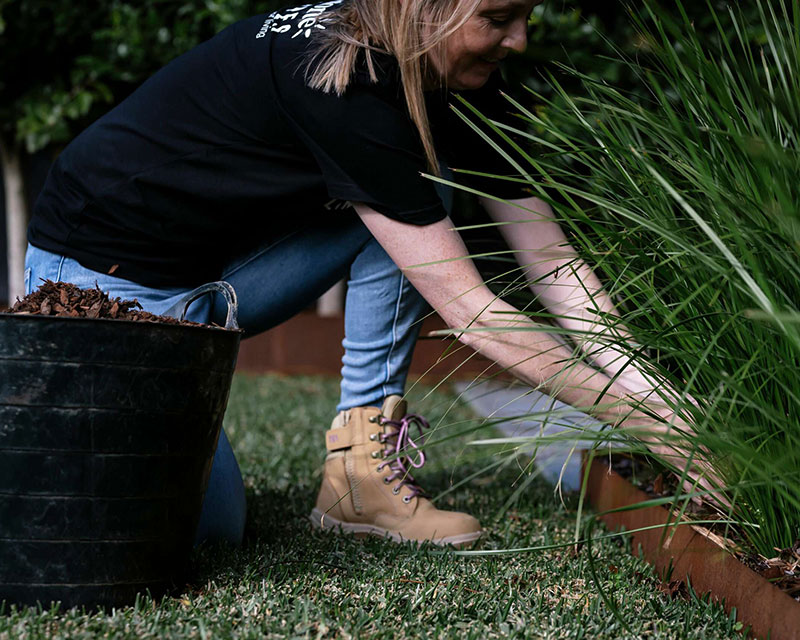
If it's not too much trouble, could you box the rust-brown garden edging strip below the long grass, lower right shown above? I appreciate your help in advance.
[587,460,800,640]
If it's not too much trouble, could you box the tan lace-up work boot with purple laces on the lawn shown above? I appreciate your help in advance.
[311,396,482,546]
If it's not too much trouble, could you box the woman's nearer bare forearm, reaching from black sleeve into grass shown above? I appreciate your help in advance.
[355,204,680,440]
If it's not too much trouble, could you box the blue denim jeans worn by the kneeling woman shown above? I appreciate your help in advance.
[25,212,426,544]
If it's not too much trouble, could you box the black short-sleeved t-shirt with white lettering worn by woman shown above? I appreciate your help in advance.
[28,1,525,287]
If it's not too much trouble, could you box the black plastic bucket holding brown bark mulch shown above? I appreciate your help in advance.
[0,283,241,607]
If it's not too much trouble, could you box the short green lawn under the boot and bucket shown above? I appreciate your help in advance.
[0,376,740,640]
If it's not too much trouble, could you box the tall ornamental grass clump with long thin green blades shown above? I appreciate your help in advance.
[450,0,800,557]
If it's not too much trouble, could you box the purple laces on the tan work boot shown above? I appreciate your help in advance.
[378,413,430,502]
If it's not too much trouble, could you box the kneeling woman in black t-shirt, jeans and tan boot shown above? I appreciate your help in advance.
[26,0,688,544]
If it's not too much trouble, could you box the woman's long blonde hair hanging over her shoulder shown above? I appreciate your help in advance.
[308,0,481,175]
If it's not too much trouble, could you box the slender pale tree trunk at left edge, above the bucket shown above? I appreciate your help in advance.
[0,137,28,306]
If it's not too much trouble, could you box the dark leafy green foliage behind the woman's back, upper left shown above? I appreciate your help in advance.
[0,0,282,153]
